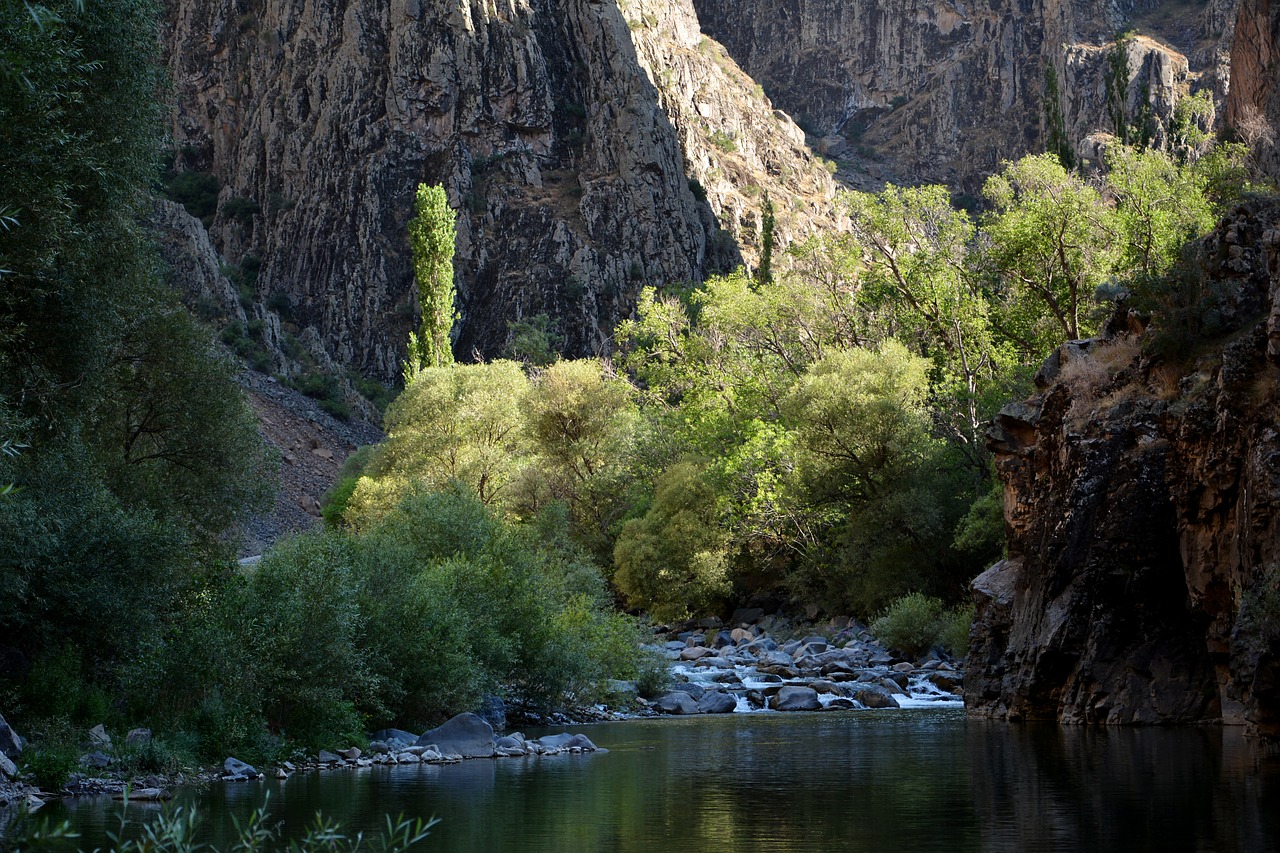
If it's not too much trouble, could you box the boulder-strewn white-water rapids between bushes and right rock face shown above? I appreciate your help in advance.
[646,610,964,715]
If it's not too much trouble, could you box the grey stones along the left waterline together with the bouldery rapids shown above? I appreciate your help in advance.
[0,608,964,812]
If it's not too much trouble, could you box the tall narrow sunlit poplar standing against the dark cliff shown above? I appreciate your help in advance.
[404,183,457,376]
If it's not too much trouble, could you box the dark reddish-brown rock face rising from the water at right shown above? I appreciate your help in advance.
[964,201,1280,735]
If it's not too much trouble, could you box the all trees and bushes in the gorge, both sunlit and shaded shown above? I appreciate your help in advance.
[0,0,1245,779]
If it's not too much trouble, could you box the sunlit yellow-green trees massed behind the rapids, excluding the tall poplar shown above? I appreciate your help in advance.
[329,143,1247,625]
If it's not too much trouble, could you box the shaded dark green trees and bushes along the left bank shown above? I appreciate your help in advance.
[0,0,646,768]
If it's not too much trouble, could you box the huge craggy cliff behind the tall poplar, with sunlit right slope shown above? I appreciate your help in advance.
[165,0,832,378]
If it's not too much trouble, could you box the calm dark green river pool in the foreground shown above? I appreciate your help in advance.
[41,708,1280,853]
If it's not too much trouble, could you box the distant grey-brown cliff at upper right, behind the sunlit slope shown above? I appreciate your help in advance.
[695,0,1238,191]
